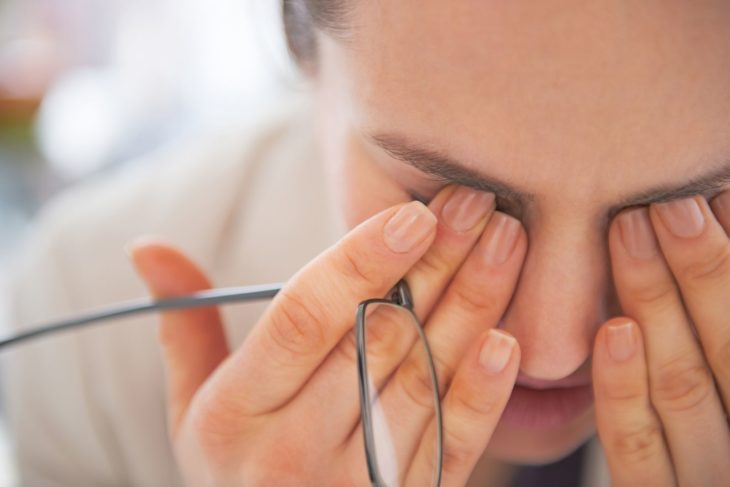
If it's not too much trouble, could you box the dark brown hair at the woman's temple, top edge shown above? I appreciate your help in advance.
[281,0,347,73]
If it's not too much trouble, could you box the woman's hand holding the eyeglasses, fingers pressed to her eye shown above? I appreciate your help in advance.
[126,187,527,486]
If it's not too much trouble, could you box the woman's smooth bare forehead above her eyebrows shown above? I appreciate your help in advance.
[332,0,730,206]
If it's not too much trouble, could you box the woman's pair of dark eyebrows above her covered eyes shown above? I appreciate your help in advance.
[370,134,730,216]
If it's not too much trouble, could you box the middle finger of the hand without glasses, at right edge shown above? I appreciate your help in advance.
[651,197,730,407]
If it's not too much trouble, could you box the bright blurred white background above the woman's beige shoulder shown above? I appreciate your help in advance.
[0,0,297,486]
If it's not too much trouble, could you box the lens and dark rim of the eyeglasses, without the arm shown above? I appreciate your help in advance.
[355,280,443,487]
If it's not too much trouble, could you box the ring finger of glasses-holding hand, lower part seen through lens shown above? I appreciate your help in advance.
[358,212,527,472]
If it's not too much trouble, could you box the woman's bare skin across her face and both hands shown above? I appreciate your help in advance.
[132,1,730,486]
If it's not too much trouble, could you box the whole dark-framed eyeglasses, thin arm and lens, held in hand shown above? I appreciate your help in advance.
[0,280,443,487]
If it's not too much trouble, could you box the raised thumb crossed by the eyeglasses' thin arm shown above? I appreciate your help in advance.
[129,240,228,435]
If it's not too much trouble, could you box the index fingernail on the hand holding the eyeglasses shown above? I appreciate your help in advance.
[383,201,436,254]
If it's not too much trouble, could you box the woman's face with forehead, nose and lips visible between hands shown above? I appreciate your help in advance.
[317,0,730,462]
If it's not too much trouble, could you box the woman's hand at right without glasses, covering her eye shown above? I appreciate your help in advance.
[593,191,730,487]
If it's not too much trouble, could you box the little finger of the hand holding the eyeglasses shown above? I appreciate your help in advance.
[404,330,520,486]
